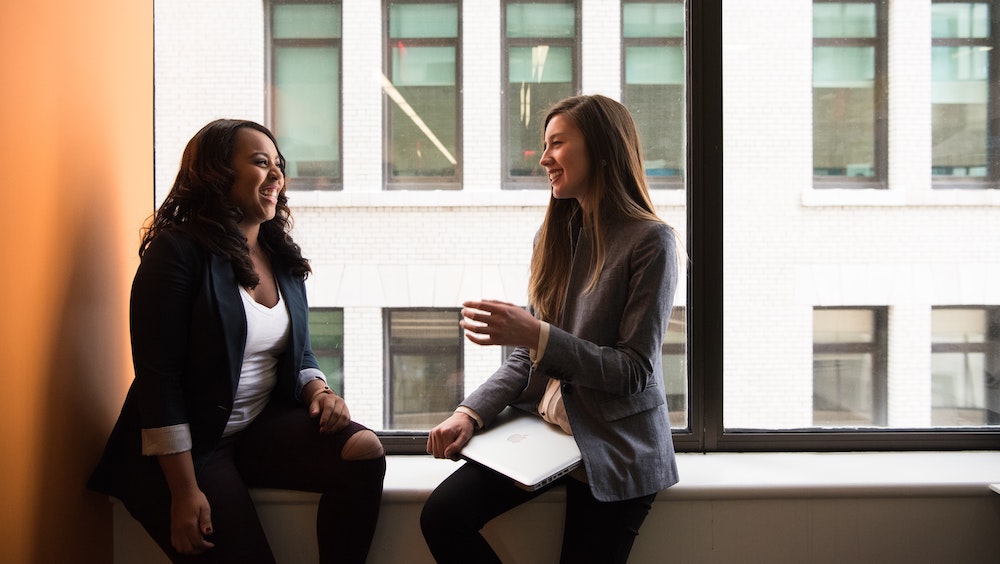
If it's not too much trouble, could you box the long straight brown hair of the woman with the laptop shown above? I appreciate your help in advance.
[528,95,662,323]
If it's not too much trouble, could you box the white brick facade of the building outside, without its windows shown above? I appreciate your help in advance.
[155,0,1000,428]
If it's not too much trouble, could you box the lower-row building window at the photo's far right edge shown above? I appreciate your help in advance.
[931,307,1000,427]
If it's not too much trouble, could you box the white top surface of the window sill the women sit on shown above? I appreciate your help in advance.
[248,451,1000,504]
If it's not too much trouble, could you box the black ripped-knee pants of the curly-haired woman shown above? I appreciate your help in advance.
[129,405,385,564]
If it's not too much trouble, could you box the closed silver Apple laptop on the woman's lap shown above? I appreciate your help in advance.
[461,407,581,491]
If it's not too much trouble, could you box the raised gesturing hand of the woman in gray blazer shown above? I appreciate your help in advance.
[458,300,541,348]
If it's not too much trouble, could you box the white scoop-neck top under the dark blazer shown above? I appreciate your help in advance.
[223,286,291,436]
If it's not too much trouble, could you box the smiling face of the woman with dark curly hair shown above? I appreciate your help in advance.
[229,127,285,230]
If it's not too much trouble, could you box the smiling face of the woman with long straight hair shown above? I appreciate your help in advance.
[539,114,591,204]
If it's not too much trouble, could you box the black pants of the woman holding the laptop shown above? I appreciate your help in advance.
[420,463,656,564]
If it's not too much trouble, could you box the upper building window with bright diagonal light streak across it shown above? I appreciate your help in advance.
[384,0,461,189]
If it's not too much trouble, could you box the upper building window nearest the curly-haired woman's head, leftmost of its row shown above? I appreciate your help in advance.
[270,0,343,189]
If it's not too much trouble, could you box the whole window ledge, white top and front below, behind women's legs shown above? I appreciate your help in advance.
[114,451,1000,564]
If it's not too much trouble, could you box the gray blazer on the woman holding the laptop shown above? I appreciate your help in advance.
[462,216,678,501]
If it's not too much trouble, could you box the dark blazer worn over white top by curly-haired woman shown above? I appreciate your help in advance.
[88,231,319,505]
